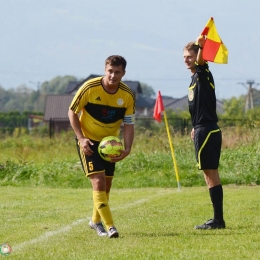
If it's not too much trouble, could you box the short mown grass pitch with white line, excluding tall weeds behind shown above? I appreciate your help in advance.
[0,186,260,260]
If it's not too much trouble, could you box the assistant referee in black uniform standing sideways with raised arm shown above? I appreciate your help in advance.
[183,37,226,229]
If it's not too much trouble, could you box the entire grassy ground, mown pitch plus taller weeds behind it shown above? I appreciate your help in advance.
[0,129,260,260]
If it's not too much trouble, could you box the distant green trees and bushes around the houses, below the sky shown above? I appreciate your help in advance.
[0,73,260,134]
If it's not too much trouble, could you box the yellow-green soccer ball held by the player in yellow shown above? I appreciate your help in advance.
[98,136,124,162]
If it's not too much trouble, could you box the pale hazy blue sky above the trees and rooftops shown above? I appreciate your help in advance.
[0,0,260,99]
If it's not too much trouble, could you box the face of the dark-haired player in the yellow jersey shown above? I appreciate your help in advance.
[104,64,125,87]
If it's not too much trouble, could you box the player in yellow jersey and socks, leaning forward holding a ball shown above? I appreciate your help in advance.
[68,55,135,238]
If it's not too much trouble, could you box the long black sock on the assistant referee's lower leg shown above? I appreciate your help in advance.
[209,184,224,223]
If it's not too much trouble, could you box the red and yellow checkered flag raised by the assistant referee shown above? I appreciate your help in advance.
[201,17,228,64]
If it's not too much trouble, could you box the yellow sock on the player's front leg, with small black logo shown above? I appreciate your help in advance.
[93,191,114,229]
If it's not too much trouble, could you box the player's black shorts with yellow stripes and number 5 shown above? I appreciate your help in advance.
[75,138,116,178]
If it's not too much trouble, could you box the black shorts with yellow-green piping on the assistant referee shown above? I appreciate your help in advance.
[194,126,222,170]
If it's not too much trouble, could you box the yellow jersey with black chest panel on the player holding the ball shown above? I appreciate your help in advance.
[70,77,135,141]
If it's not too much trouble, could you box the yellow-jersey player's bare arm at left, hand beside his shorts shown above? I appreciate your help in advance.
[68,109,93,155]
